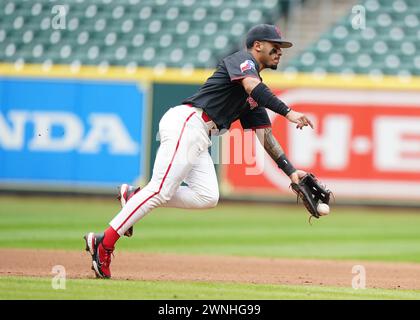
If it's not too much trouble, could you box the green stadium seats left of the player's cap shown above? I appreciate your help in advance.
[0,0,282,68]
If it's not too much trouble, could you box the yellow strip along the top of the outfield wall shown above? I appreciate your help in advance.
[0,63,420,91]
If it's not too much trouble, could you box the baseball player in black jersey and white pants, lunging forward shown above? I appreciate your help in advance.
[84,24,313,278]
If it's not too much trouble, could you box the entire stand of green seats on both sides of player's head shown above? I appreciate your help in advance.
[0,0,420,75]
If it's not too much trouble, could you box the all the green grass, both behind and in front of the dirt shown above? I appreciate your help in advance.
[0,197,420,299]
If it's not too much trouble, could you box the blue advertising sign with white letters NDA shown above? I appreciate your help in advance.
[0,78,147,188]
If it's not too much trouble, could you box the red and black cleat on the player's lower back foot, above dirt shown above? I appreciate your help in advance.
[83,232,114,279]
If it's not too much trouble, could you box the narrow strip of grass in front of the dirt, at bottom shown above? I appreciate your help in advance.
[0,277,420,300]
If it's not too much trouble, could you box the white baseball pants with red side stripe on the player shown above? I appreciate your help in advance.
[110,105,219,236]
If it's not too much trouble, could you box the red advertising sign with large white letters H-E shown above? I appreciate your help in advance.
[222,88,420,200]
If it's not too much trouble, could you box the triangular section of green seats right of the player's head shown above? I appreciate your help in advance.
[285,0,420,76]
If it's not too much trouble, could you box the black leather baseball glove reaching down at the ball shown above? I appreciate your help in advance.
[290,173,332,219]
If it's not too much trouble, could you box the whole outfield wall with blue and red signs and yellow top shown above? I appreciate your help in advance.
[0,65,420,204]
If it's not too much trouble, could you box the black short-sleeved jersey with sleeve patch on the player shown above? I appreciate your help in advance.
[182,51,271,131]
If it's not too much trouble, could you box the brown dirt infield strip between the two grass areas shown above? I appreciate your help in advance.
[0,249,420,289]
